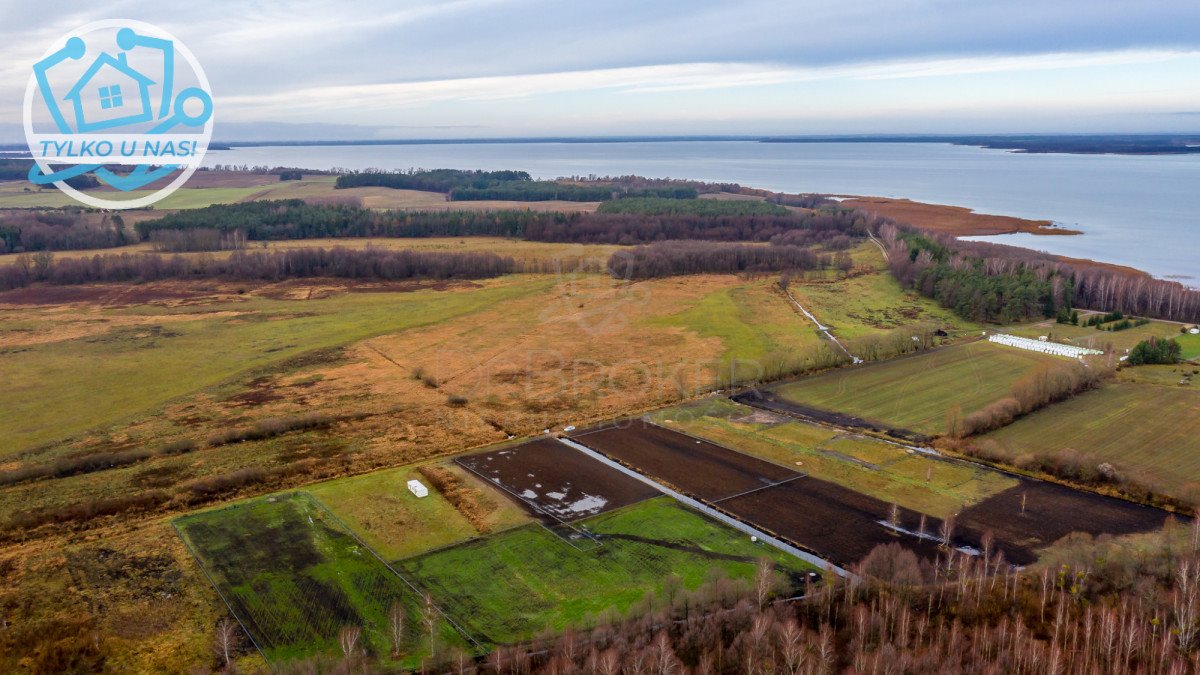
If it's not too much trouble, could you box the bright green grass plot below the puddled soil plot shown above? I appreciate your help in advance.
[400,497,810,643]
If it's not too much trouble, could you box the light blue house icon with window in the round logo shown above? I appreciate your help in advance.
[64,52,154,133]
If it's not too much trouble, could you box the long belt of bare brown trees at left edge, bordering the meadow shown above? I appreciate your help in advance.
[0,246,516,291]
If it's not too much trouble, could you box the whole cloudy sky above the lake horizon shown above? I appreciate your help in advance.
[0,0,1200,142]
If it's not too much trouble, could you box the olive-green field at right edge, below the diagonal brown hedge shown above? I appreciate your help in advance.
[983,381,1200,498]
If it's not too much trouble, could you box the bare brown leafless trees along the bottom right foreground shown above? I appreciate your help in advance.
[276,522,1200,675]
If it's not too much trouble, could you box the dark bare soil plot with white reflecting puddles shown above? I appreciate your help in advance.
[455,438,660,521]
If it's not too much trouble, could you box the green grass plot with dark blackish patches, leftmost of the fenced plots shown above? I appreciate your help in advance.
[175,492,464,667]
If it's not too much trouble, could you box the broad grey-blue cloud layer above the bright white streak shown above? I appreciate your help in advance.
[0,0,1200,136]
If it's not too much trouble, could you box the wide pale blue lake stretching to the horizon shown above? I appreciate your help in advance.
[205,141,1200,279]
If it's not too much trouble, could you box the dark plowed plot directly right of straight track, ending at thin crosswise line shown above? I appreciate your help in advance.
[571,420,800,501]
